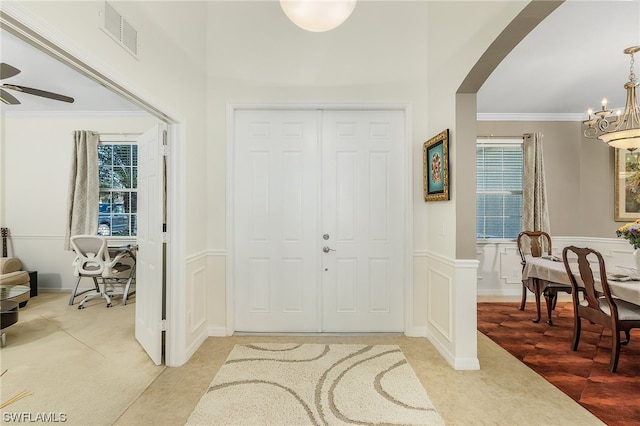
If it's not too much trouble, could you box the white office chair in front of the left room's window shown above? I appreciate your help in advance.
[69,235,135,309]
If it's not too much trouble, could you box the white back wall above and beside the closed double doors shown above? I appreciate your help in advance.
[208,2,428,340]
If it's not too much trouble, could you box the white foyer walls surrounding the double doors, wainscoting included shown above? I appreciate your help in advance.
[2,1,528,368]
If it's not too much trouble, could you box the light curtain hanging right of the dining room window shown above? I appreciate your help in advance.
[522,133,551,234]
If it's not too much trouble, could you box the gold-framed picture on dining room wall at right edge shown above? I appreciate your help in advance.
[613,148,640,222]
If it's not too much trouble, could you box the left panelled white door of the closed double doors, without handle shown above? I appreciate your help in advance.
[234,111,319,332]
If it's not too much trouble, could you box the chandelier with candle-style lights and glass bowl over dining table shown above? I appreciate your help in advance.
[583,46,640,151]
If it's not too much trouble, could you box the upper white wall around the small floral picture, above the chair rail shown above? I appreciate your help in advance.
[424,1,527,258]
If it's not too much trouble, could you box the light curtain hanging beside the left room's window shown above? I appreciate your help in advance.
[64,130,100,250]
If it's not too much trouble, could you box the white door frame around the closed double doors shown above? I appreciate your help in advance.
[225,102,413,336]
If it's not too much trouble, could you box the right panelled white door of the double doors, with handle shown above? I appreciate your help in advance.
[322,111,405,332]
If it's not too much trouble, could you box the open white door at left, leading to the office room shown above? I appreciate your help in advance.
[135,125,165,365]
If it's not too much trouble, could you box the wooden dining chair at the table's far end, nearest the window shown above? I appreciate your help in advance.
[516,231,571,325]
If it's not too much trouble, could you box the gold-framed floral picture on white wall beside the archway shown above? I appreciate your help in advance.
[422,129,449,201]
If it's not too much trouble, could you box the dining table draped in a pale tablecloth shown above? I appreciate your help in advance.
[522,256,640,305]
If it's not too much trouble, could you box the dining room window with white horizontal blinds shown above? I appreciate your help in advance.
[476,139,523,239]
